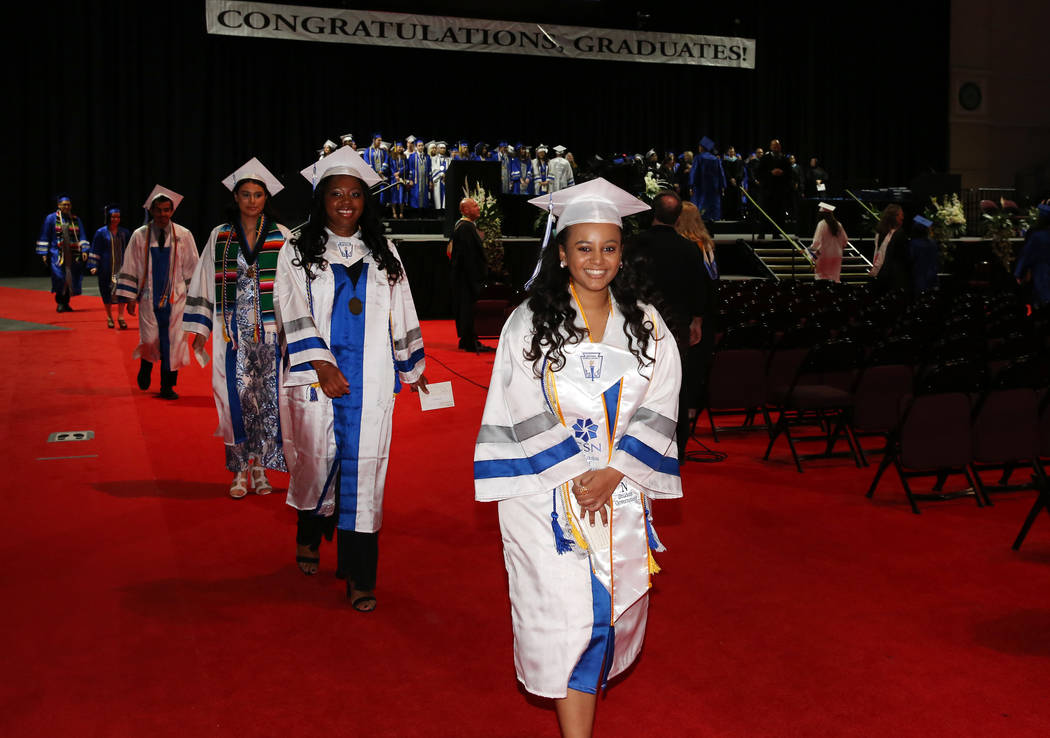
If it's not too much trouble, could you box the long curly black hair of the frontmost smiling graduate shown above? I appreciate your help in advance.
[524,226,673,377]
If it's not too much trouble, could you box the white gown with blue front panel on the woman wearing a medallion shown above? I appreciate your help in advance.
[274,231,424,532]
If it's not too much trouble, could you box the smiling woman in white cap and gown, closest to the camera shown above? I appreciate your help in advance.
[475,178,681,736]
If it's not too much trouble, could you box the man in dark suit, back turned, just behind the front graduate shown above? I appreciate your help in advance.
[633,190,708,463]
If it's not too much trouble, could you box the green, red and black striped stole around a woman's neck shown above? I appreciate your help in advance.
[215,219,285,341]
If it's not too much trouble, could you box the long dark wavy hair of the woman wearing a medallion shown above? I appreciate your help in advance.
[292,175,404,284]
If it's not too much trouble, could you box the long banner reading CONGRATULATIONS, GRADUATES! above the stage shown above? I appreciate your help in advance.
[205,0,755,69]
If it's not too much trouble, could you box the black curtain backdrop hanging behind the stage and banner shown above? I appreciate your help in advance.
[8,0,950,276]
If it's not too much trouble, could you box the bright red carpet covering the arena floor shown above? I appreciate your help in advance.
[0,289,1050,738]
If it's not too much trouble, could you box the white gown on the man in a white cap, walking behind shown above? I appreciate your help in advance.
[113,223,197,372]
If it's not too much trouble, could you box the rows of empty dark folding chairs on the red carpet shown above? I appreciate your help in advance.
[702,280,1050,546]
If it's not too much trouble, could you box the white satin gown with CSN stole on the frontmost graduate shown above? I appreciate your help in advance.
[475,304,681,697]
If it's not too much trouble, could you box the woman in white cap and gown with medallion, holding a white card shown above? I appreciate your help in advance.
[275,147,427,612]
